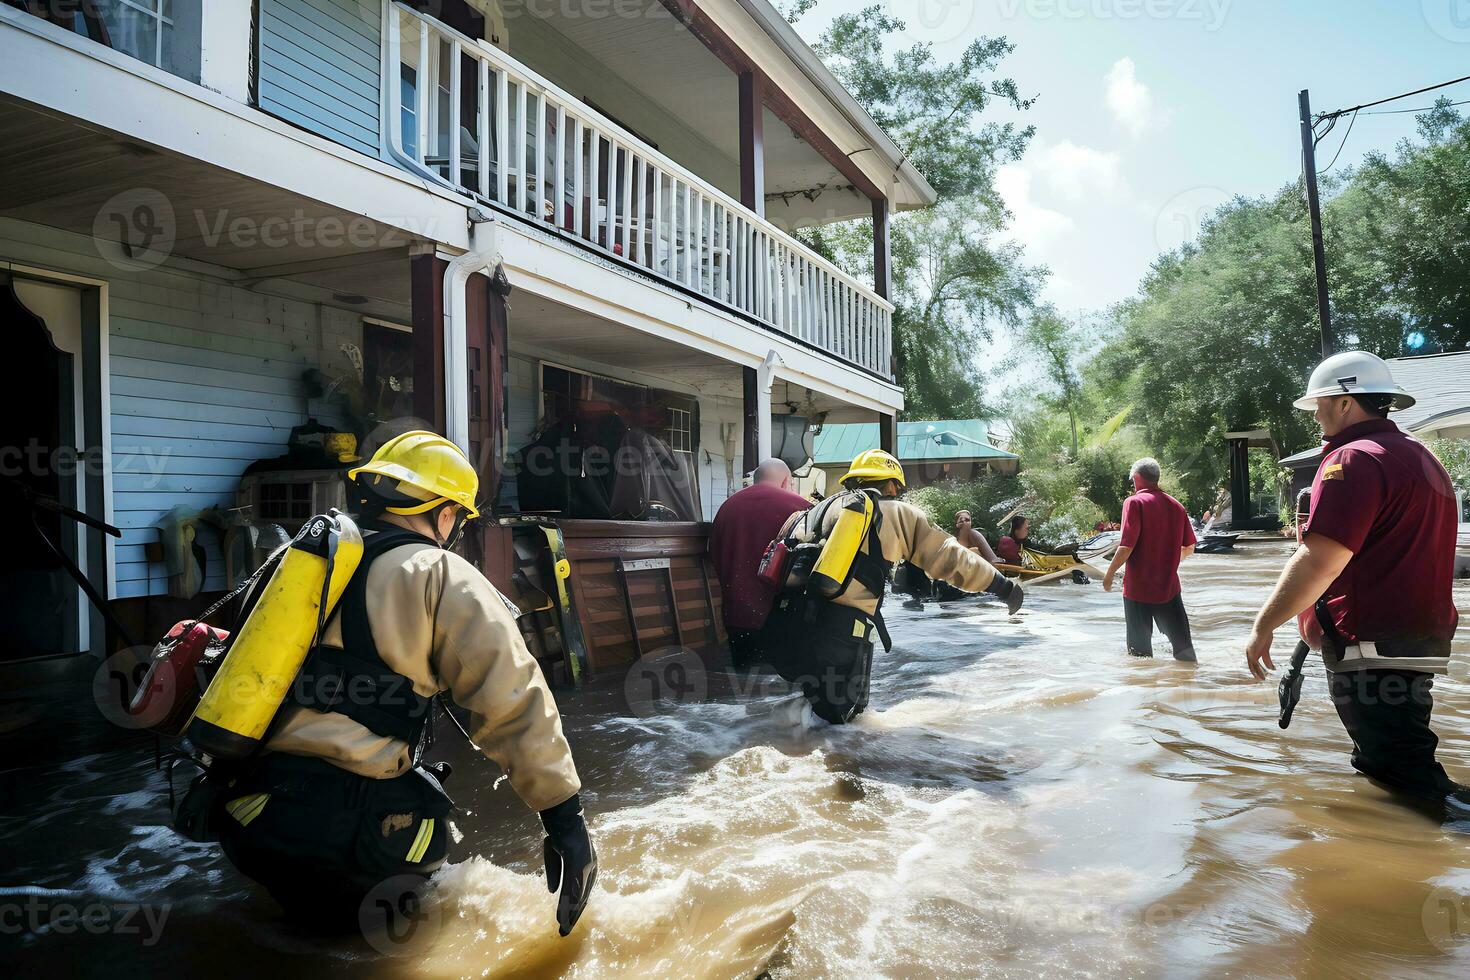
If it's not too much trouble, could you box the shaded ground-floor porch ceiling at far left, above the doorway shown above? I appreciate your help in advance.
[0,96,410,303]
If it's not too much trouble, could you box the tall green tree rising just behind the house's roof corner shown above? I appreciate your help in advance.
[788,0,1045,417]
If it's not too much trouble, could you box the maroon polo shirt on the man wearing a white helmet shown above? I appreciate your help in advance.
[1302,419,1460,642]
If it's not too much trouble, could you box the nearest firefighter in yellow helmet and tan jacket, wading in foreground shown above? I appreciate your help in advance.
[212,430,597,936]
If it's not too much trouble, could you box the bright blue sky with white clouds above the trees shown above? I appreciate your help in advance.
[797,0,1470,321]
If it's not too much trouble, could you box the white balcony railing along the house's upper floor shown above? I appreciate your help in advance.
[384,3,892,378]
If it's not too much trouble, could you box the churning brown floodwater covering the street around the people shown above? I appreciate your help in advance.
[0,542,1470,979]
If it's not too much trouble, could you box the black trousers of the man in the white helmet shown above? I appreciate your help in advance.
[1327,670,1460,799]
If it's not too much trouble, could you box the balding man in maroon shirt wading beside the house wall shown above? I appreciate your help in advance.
[710,460,811,667]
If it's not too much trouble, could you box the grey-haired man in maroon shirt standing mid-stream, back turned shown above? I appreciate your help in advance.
[1103,457,1195,663]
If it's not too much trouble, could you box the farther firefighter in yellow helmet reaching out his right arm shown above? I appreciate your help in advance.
[770,450,1025,724]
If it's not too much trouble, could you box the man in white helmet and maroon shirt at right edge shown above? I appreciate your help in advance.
[1245,351,1470,801]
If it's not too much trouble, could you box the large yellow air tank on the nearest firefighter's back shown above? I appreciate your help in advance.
[188,510,363,760]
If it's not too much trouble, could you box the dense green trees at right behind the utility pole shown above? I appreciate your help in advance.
[1080,106,1470,508]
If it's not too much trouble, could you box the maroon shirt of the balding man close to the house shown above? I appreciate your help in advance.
[710,483,811,629]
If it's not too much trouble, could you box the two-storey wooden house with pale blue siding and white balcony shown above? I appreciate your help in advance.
[0,0,933,678]
